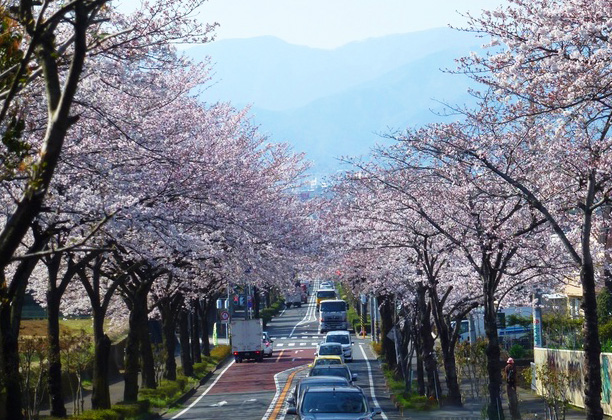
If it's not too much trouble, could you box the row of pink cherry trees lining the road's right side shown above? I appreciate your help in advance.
[329,0,612,419]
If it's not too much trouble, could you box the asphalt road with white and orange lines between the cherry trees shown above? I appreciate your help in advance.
[163,288,401,420]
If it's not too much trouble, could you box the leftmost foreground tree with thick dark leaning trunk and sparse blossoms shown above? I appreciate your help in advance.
[0,0,218,419]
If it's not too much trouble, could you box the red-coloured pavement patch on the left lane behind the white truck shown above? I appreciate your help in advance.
[208,348,315,395]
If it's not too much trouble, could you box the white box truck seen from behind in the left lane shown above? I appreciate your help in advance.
[230,319,264,363]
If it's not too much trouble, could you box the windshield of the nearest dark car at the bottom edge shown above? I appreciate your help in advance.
[302,391,367,413]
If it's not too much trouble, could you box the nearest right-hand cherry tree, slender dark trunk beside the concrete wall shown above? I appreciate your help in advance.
[460,0,612,419]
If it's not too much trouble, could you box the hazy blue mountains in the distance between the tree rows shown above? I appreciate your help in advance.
[186,28,482,175]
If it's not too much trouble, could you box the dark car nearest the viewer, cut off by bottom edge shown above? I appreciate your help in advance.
[287,386,381,420]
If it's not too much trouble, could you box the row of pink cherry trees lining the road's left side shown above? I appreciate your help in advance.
[0,0,316,419]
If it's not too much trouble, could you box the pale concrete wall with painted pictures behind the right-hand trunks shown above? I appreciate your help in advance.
[533,348,612,415]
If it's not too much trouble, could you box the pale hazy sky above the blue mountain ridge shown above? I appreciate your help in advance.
[114,0,504,48]
